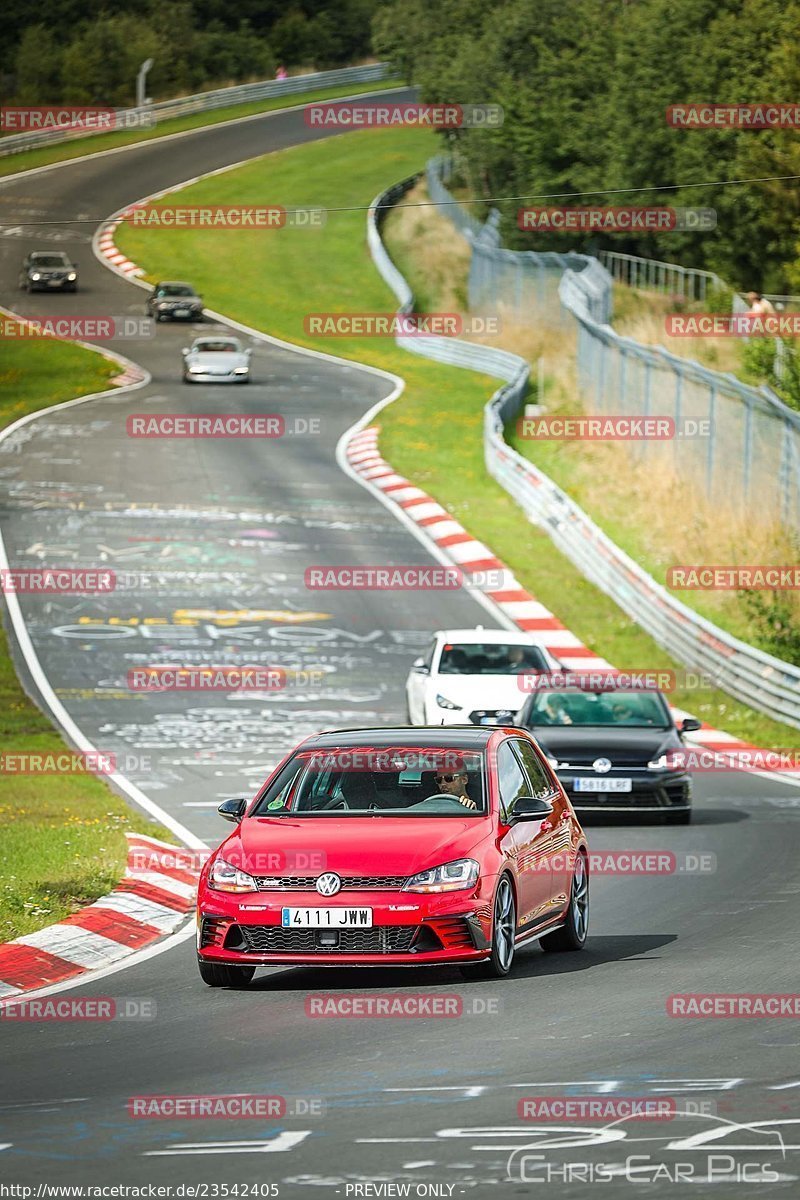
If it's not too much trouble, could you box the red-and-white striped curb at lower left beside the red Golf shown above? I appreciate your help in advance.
[0,834,205,1003]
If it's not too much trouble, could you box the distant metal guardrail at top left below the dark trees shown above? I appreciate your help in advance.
[0,62,390,156]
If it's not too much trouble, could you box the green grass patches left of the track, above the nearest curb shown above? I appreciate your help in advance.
[0,338,174,941]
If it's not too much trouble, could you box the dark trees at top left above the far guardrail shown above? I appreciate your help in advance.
[6,0,379,106]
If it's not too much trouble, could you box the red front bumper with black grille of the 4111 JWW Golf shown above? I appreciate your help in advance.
[197,883,492,966]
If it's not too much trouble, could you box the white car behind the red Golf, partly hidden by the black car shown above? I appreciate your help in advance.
[405,628,561,725]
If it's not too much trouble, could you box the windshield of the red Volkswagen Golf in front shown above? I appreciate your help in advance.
[252,746,487,817]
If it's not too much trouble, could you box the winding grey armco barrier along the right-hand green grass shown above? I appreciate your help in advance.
[367,176,800,728]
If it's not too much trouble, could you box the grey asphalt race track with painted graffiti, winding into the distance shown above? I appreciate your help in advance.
[0,91,800,1196]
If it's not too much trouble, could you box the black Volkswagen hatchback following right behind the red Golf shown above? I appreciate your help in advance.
[517,690,700,824]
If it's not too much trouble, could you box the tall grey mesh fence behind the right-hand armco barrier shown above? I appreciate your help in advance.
[428,158,800,529]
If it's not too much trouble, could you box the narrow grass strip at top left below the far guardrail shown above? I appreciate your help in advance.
[0,79,398,176]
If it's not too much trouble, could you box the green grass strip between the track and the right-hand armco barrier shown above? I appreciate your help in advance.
[118,130,800,748]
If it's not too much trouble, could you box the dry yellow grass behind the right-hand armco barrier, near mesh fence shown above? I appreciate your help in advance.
[386,182,800,638]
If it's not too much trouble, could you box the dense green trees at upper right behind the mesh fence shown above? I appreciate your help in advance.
[373,0,800,292]
